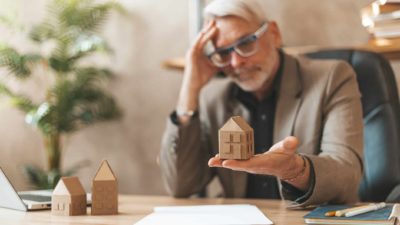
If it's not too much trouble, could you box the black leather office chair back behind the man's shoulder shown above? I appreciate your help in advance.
[306,49,400,202]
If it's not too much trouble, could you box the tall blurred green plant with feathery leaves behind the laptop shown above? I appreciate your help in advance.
[0,0,122,188]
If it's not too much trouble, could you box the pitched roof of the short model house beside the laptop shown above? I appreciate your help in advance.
[53,177,86,195]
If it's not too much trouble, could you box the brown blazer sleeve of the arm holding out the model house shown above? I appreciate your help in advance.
[293,62,363,207]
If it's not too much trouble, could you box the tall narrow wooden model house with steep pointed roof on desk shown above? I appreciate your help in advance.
[92,160,118,215]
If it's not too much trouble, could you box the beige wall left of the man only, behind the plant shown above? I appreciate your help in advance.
[0,0,188,194]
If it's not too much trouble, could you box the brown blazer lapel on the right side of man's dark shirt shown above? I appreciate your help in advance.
[273,53,302,143]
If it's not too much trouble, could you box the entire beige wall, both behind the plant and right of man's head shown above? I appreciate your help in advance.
[0,0,400,194]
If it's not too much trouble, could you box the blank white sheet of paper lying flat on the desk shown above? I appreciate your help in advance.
[135,205,273,225]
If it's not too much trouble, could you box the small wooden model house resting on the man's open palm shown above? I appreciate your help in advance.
[218,116,254,159]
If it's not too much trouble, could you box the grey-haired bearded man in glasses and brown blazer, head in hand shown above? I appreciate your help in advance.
[160,0,363,206]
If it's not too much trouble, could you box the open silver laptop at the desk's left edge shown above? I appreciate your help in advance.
[0,167,91,211]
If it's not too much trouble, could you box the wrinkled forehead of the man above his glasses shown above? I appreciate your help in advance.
[213,16,259,48]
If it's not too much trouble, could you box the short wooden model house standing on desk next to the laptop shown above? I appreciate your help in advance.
[51,177,86,216]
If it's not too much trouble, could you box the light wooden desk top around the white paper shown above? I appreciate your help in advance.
[0,195,308,225]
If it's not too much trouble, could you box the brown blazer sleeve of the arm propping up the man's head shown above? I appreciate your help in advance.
[159,112,213,197]
